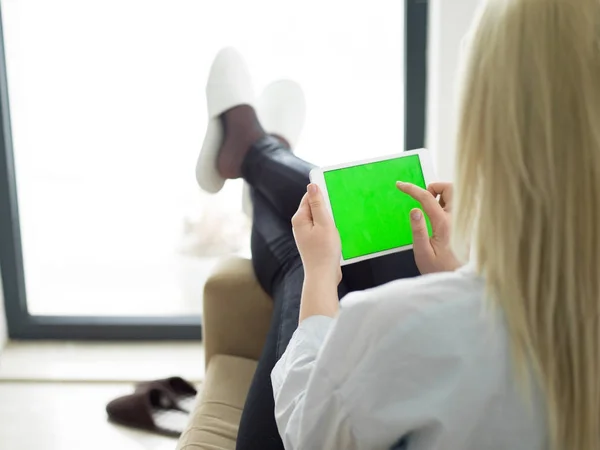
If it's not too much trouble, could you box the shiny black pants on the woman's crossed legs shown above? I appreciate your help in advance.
[237,137,419,450]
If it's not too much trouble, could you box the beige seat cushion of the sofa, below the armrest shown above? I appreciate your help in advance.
[177,355,256,450]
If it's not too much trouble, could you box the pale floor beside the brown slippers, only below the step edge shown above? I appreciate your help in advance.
[0,382,189,450]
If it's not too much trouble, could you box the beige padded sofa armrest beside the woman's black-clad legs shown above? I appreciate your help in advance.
[202,257,273,367]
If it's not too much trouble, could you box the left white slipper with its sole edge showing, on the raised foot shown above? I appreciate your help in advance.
[196,47,255,194]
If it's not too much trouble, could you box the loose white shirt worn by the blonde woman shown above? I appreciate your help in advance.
[271,268,548,450]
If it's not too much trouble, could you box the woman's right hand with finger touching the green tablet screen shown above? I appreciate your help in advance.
[397,181,460,274]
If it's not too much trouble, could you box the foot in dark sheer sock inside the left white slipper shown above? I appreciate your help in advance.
[217,105,266,179]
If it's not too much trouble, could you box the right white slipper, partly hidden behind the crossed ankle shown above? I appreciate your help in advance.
[242,80,306,218]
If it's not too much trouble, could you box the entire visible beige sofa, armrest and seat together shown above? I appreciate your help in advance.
[177,258,272,450]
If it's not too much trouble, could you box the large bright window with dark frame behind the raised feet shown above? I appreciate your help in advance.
[0,0,427,338]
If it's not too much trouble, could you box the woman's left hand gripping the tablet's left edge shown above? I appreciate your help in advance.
[292,184,342,286]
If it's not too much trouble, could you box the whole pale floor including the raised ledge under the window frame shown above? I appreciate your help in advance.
[0,342,204,450]
